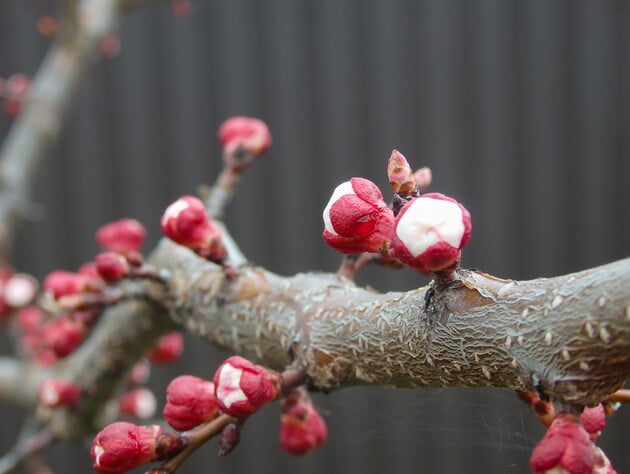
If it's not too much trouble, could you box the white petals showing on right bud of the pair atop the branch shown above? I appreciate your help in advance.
[396,198,464,257]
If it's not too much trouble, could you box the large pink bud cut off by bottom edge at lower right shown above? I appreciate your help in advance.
[529,414,595,474]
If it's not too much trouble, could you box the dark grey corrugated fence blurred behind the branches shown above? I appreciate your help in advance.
[0,0,630,474]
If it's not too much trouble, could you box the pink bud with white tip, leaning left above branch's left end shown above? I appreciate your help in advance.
[161,196,227,262]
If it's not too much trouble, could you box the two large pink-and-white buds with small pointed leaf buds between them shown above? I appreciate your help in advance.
[323,150,471,274]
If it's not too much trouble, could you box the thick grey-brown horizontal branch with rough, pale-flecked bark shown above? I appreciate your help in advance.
[154,242,630,405]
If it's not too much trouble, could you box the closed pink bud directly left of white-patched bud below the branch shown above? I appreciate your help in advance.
[164,375,221,431]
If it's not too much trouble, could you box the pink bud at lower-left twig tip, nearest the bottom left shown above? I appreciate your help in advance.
[90,421,162,474]
